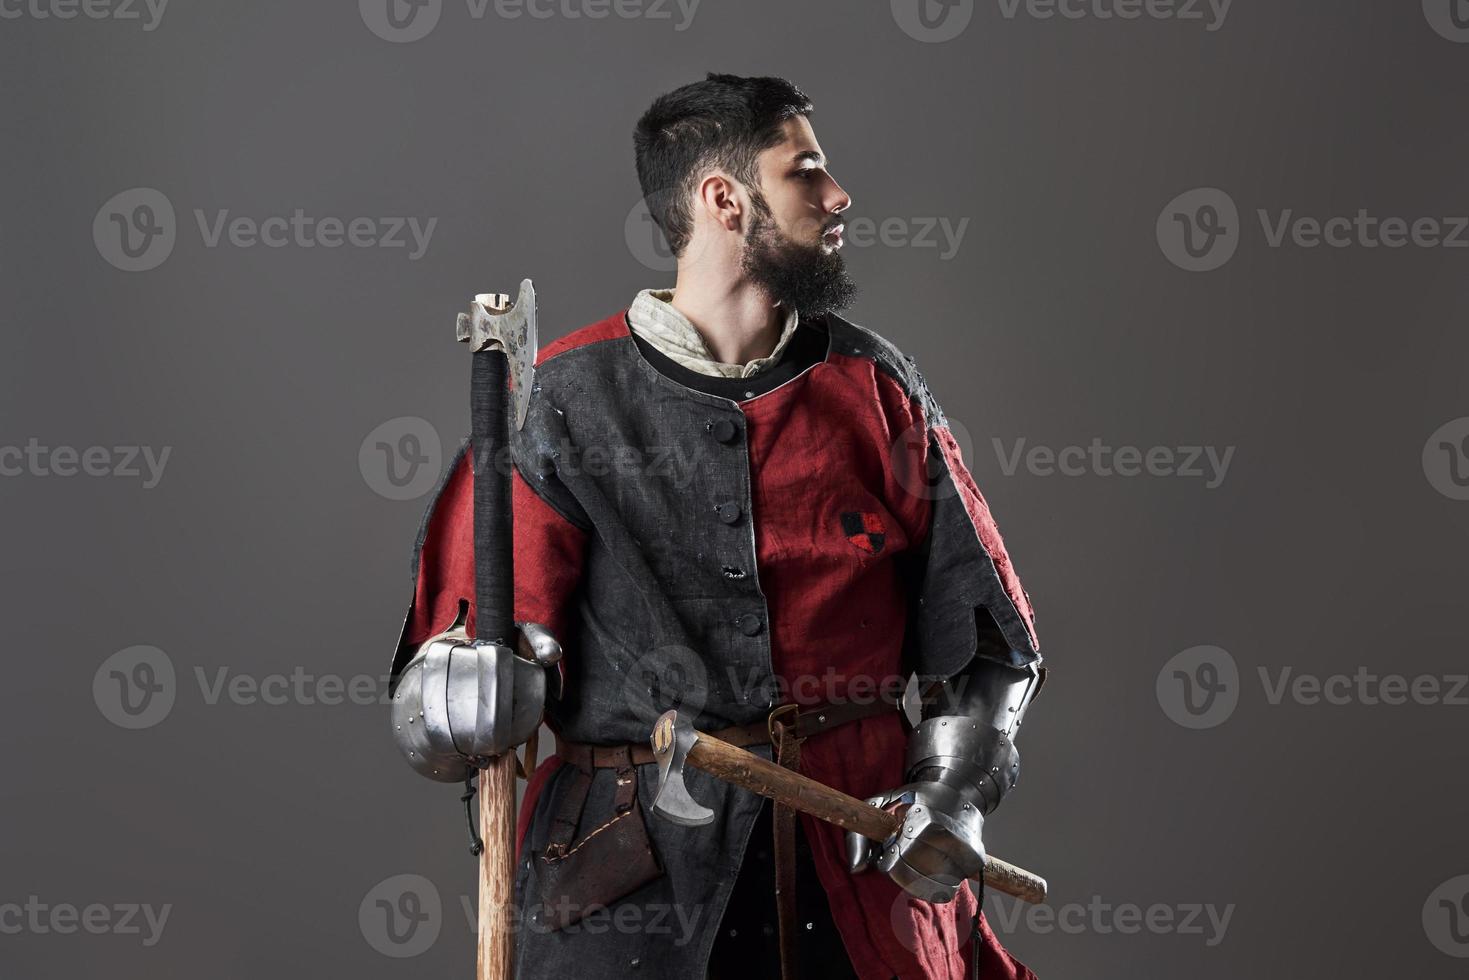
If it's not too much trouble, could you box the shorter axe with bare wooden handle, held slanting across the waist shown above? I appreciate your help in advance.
[649,711,1046,904]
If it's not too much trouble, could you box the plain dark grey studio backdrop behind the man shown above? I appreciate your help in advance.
[0,0,1469,980]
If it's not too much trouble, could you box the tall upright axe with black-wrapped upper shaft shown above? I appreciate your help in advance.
[455,279,536,980]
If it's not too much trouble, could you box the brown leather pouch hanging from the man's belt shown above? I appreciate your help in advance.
[532,758,664,930]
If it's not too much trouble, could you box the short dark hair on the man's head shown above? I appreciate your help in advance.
[633,72,811,256]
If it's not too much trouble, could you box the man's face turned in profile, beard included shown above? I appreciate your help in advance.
[740,116,856,316]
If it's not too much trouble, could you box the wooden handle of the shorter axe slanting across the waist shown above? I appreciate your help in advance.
[685,719,1046,905]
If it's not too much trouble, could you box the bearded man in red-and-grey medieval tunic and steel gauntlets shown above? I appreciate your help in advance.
[394,73,1044,980]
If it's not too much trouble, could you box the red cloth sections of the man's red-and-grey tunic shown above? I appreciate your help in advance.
[408,313,1034,980]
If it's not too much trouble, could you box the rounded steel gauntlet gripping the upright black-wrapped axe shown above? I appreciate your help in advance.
[391,604,561,783]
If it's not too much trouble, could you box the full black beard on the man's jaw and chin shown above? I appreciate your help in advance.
[740,204,856,320]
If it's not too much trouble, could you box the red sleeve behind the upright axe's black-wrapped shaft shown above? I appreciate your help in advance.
[404,453,586,646]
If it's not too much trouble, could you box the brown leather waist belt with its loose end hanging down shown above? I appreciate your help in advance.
[555,698,900,980]
